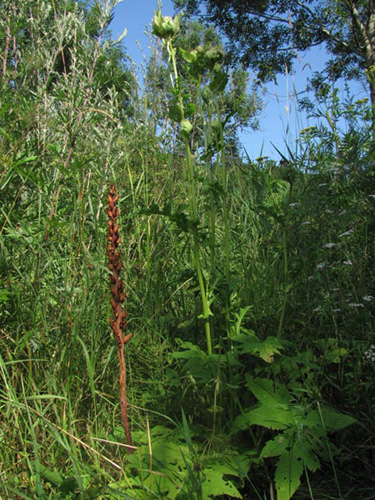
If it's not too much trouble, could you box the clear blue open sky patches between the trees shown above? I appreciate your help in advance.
[111,0,367,159]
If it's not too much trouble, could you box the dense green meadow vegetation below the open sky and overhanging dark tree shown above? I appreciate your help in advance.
[0,0,375,500]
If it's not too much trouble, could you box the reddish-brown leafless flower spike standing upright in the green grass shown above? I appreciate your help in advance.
[107,186,133,453]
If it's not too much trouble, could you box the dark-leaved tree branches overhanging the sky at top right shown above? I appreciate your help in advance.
[175,0,375,134]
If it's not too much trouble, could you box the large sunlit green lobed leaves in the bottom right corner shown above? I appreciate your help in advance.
[233,368,355,500]
